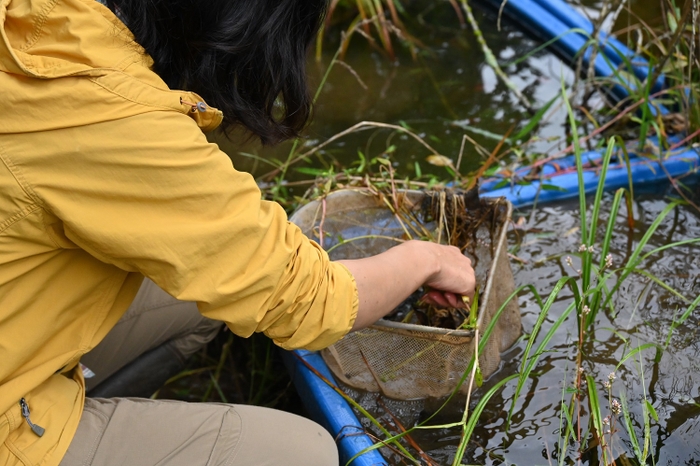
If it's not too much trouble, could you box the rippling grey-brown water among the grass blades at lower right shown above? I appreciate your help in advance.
[473,194,700,465]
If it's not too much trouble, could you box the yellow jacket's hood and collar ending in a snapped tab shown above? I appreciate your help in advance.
[0,0,223,131]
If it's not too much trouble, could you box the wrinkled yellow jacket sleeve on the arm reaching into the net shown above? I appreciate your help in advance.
[22,111,358,349]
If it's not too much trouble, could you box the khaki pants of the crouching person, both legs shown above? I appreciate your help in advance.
[61,280,338,466]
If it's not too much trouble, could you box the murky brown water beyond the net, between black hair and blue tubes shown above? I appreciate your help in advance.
[217,0,573,179]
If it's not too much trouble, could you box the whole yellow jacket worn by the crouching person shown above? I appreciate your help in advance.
[0,0,358,466]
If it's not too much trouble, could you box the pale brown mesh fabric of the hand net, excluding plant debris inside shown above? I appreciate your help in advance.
[291,190,521,400]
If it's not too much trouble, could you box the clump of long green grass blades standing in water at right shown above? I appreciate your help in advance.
[509,85,700,465]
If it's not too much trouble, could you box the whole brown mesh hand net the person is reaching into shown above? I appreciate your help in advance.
[291,189,521,400]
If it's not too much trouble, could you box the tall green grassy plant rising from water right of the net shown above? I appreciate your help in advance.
[509,84,700,465]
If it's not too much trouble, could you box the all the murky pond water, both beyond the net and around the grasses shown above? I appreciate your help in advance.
[278,0,700,465]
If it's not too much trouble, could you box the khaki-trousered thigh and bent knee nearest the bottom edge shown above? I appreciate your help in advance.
[61,398,338,466]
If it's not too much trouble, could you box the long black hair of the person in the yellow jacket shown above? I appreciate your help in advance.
[107,0,326,144]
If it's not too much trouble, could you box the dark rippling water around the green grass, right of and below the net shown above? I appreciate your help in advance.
[350,190,700,465]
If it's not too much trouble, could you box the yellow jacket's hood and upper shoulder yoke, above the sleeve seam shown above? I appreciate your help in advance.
[0,0,223,134]
